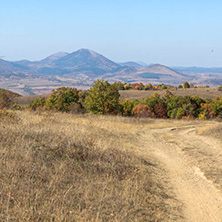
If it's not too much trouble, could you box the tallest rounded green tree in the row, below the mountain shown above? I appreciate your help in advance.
[85,79,120,114]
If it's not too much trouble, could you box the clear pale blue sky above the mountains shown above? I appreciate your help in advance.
[0,0,222,67]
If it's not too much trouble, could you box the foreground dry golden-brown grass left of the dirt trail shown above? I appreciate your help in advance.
[0,112,180,222]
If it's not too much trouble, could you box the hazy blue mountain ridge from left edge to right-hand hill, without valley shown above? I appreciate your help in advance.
[0,48,181,78]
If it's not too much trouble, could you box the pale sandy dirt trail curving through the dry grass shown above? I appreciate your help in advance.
[142,125,222,222]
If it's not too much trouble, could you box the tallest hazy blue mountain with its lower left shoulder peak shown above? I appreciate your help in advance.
[11,49,121,77]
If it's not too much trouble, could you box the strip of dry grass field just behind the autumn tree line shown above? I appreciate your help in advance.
[120,88,222,100]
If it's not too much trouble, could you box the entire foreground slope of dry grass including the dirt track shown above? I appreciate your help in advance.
[0,111,222,222]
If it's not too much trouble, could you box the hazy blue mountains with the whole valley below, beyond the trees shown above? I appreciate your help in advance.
[0,49,222,95]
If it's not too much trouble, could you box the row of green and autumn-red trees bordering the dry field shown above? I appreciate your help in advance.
[29,80,222,119]
